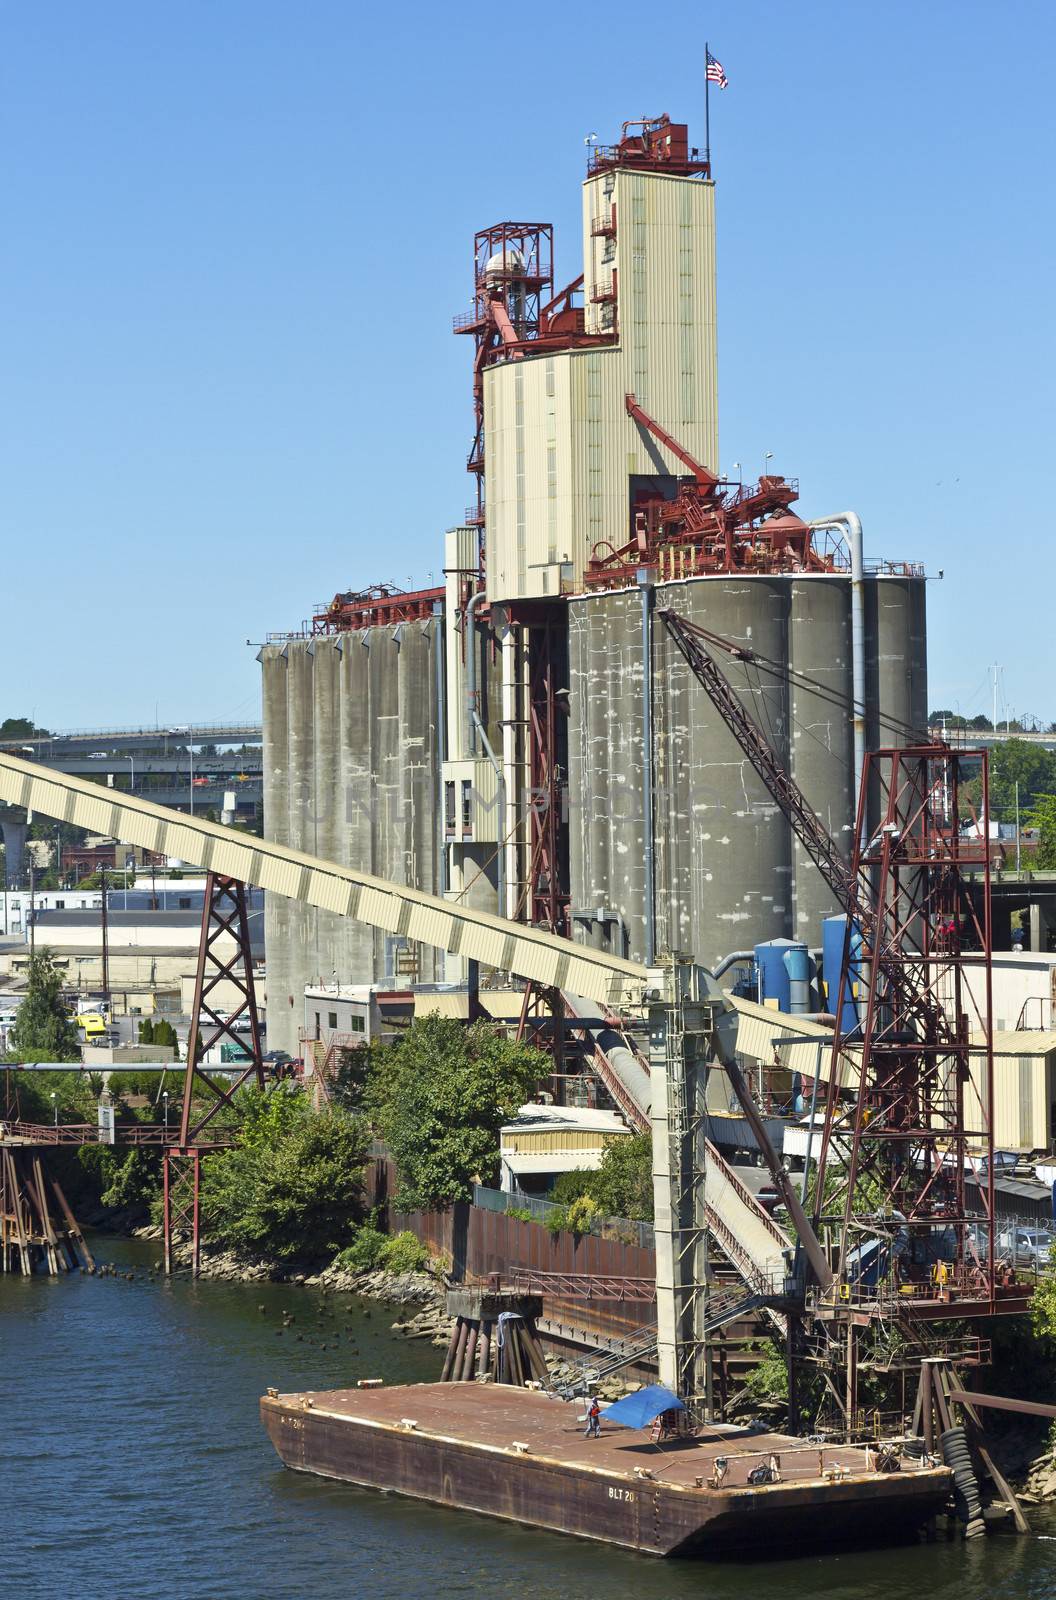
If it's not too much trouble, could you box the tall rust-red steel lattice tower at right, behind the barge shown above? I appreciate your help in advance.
[816,744,992,1315]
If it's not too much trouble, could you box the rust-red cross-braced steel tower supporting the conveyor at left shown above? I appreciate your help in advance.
[162,872,264,1277]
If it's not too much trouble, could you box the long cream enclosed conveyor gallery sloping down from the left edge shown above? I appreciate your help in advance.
[0,754,648,1006]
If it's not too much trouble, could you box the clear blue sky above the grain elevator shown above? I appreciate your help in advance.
[0,0,1056,728]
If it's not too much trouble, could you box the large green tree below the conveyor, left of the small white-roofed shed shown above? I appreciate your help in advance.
[366,1016,550,1211]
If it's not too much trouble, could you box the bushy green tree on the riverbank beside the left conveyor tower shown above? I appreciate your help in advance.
[202,1086,370,1261]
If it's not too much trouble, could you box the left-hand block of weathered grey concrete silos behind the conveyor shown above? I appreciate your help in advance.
[268,621,442,1056]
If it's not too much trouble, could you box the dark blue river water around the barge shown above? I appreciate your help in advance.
[0,1240,1056,1600]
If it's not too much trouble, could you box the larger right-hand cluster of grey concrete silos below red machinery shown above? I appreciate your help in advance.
[570,576,926,965]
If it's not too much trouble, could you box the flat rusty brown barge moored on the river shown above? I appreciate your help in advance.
[261,1382,950,1555]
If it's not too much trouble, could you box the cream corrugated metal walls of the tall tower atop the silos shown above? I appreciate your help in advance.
[485,171,718,600]
